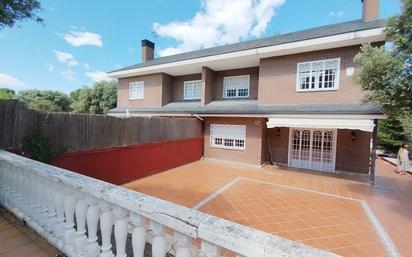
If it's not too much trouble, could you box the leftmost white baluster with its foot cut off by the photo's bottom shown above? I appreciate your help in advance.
[99,201,114,257]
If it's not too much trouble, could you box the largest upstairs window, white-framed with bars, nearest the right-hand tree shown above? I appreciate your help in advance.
[296,58,340,92]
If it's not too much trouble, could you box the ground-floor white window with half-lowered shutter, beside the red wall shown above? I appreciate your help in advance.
[210,124,246,150]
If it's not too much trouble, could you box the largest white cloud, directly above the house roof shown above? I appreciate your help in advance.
[153,0,286,56]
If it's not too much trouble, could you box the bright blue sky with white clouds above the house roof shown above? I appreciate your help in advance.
[0,0,400,93]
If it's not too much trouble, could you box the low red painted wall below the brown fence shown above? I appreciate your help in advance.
[53,137,203,185]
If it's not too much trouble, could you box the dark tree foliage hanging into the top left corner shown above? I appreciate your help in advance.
[0,0,43,29]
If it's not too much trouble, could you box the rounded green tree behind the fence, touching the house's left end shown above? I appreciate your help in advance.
[70,81,117,114]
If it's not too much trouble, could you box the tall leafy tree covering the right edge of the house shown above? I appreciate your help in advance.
[355,0,412,152]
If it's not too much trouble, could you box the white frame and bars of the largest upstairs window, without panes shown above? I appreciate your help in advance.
[296,58,341,92]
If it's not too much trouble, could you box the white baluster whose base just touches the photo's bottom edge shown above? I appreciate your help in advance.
[85,197,100,257]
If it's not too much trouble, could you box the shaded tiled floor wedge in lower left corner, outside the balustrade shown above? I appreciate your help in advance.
[0,206,59,257]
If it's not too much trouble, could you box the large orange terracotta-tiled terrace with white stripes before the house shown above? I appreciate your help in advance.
[124,160,412,256]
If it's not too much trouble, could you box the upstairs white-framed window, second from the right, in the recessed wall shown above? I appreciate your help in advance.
[223,75,250,98]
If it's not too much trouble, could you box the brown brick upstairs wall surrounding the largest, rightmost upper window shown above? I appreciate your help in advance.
[259,46,364,104]
